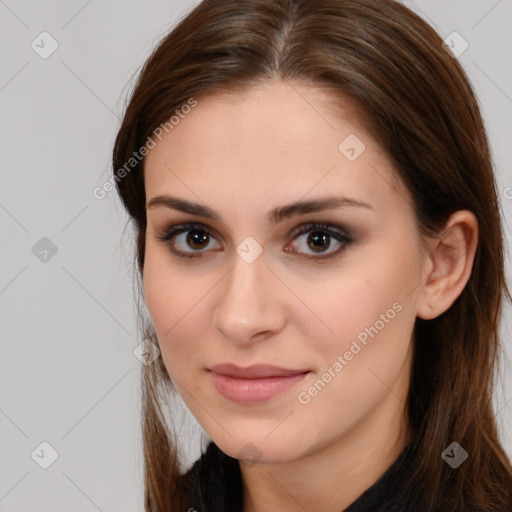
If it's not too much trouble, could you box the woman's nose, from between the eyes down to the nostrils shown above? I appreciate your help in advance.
[212,250,286,345]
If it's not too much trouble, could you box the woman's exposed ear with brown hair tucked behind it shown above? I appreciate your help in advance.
[417,210,478,320]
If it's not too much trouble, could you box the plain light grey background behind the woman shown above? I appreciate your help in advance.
[0,0,512,512]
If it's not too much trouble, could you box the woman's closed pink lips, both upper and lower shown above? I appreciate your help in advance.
[209,363,309,404]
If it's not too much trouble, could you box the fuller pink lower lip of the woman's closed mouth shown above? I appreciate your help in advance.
[211,372,309,404]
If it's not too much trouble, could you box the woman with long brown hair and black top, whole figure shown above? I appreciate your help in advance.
[113,0,512,512]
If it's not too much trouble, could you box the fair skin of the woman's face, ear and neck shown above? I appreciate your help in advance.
[143,81,477,512]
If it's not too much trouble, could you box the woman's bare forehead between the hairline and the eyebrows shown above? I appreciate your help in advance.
[144,81,407,221]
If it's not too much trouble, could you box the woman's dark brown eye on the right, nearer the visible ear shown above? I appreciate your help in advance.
[287,223,353,259]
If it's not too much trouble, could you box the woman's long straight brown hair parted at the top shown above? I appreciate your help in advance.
[113,0,512,512]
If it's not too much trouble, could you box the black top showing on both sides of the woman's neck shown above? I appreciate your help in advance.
[180,441,512,512]
